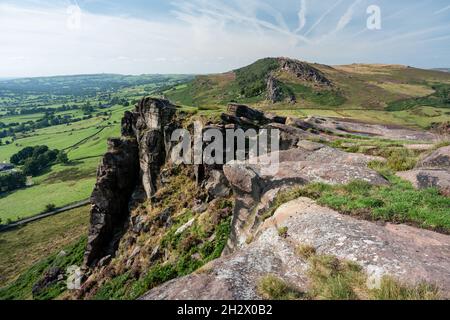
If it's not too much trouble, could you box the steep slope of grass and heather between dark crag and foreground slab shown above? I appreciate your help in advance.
[87,168,233,300]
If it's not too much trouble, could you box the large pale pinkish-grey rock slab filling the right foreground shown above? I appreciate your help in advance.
[142,198,450,300]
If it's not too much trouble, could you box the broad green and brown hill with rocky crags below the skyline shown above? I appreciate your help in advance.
[163,58,450,110]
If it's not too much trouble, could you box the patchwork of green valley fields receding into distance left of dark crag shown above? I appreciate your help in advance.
[0,76,188,223]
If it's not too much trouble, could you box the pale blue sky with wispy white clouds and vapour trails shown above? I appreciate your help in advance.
[0,0,450,78]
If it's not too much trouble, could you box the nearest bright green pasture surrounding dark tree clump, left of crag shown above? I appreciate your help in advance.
[0,106,127,221]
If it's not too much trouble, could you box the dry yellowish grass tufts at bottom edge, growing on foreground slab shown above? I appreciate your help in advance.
[257,252,440,300]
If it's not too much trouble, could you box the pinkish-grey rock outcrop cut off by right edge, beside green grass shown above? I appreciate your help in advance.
[397,147,450,196]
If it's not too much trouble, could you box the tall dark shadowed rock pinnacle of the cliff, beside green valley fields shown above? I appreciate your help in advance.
[85,98,177,267]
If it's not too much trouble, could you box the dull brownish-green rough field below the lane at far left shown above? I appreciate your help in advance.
[0,206,89,287]
